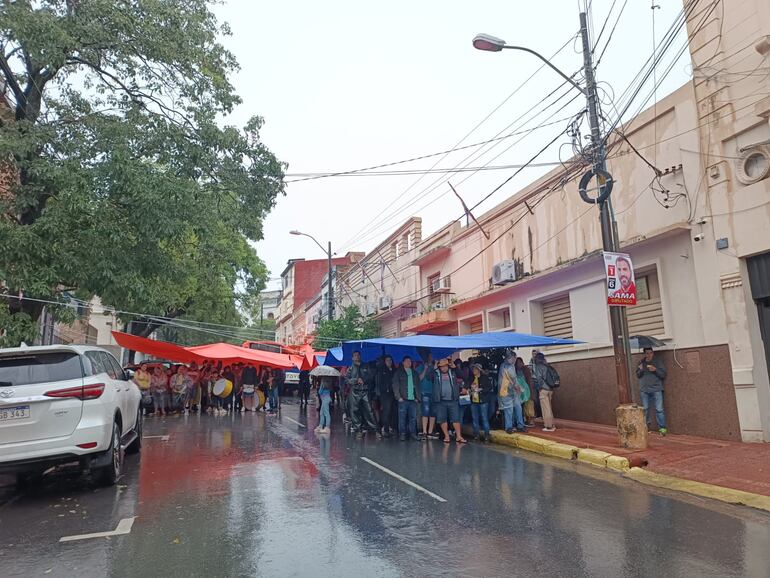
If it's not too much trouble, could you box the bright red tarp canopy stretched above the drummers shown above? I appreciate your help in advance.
[112,331,294,369]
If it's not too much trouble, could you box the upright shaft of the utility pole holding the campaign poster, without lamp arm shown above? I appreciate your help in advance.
[580,12,631,405]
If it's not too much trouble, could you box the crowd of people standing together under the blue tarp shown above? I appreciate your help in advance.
[300,350,559,444]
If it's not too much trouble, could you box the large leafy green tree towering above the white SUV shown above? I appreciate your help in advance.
[0,0,285,341]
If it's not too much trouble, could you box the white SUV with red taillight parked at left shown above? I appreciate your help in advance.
[0,345,142,485]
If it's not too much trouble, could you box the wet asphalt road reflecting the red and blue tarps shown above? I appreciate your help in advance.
[0,403,770,578]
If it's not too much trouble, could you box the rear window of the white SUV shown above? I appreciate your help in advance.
[0,351,83,387]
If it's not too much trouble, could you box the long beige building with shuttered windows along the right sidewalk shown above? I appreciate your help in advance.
[362,0,770,441]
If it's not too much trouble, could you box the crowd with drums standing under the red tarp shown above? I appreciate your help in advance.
[133,362,284,416]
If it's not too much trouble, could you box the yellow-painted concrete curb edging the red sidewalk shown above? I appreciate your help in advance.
[489,431,770,512]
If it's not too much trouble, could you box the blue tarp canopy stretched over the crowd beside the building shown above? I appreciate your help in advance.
[324,332,582,366]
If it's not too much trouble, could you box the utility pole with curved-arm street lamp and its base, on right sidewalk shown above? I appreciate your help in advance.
[473,12,647,447]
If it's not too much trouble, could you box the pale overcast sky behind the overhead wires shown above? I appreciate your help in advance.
[212,0,690,287]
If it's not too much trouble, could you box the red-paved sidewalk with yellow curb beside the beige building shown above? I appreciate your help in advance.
[484,419,770,511]
